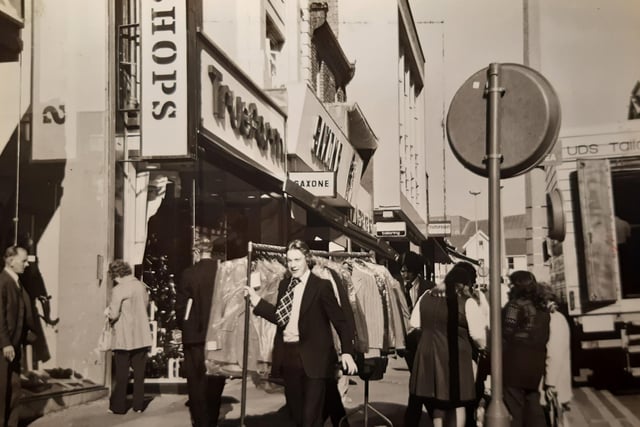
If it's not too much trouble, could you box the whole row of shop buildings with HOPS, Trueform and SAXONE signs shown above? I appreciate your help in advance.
[0,0,410,414]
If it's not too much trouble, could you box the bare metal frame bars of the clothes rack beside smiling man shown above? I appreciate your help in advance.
[240,241,375,427]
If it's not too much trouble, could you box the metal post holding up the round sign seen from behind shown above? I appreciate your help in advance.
[486,63,510,427]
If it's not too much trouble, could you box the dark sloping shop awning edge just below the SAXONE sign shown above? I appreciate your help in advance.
[283,179,398,259]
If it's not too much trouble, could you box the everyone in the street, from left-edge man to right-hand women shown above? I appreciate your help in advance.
[0,239,572,427]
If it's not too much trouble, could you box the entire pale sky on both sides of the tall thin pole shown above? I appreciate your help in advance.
[409,0,640,219]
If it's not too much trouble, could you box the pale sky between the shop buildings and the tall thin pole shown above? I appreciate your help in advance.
[410,0,525,219]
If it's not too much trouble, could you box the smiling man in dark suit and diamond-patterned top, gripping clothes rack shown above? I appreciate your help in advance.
[245,240,357,427]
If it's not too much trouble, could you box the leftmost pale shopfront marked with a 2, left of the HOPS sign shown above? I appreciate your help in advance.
[0,1,116,407]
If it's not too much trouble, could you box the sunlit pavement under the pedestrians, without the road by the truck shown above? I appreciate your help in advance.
[23,358,424,427]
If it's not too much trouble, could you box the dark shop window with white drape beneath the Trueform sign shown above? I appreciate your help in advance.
[123,150,286,382]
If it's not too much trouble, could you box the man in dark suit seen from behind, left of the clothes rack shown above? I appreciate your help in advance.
[176,238,225,427]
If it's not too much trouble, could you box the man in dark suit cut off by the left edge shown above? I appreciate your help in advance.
[0,246,35,427]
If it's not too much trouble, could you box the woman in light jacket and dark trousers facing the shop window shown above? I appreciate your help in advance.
[104,260,151,414]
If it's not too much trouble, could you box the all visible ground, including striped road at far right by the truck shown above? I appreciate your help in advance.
[22,358,640,427]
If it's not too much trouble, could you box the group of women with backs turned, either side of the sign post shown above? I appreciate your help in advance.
[405,262,572,427]
